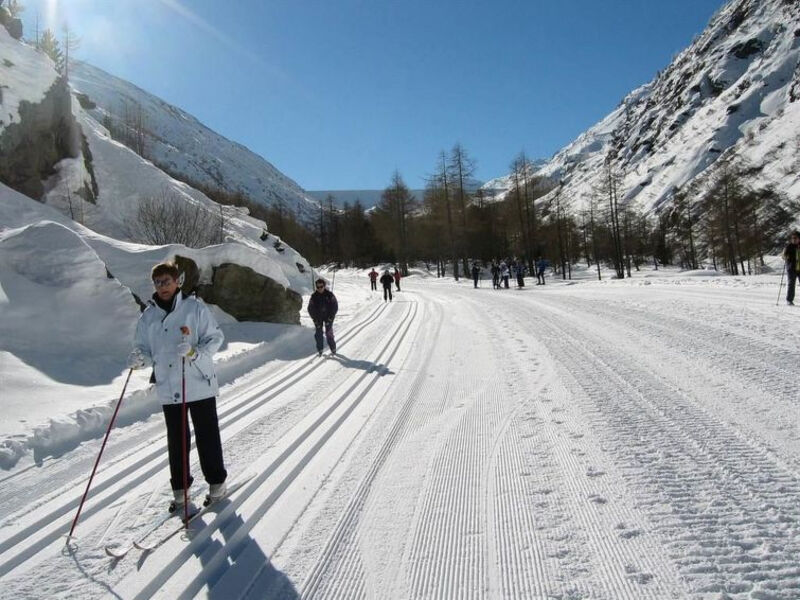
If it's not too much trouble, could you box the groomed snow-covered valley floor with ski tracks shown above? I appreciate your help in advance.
[0,271,800,600]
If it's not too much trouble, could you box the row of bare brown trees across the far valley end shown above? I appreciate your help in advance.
[268,144,800,279]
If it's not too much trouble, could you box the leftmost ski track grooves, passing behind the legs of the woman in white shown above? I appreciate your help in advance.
[0,305,386,592]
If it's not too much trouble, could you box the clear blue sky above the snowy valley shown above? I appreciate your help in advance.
[24,0,723,190]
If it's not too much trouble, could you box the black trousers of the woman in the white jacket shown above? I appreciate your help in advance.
[163,397,228,490]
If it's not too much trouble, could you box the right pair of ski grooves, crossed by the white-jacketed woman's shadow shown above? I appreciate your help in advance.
[116,302,418,598]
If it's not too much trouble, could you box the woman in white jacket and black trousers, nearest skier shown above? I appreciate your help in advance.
[128,263,228,512]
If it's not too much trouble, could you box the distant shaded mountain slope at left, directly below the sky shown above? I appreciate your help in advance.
[70,63,315,212]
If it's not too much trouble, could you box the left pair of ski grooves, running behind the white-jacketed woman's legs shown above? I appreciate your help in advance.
[0,304,387,578]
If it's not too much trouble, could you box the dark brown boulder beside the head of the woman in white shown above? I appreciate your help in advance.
[175,256,303,324]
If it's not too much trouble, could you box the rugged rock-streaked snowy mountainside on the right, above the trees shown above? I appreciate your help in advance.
[484,0,800,211]
